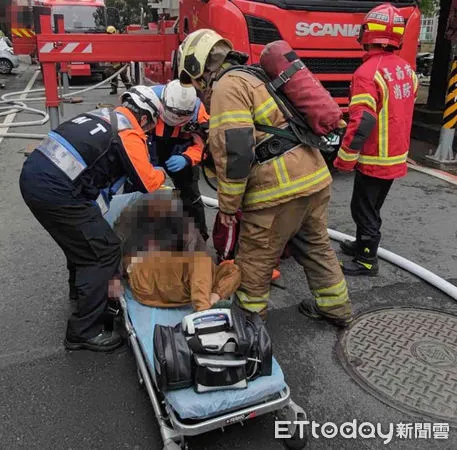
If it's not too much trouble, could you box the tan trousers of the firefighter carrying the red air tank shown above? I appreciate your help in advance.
[235,187,351,318]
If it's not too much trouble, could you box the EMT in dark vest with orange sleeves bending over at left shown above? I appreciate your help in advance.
[20,86,165,351]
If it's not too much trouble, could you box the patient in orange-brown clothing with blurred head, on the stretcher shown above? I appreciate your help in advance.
[115,191,241,311]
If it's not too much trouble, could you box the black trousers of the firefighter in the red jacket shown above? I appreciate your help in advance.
[351,171,393,254]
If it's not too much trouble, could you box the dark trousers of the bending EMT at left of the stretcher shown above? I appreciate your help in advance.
[23,195,121,341]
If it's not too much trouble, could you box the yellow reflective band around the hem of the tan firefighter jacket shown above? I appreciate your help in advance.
[243,166,330,206]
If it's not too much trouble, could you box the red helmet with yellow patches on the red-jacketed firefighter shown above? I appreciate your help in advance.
[359,3,406,48]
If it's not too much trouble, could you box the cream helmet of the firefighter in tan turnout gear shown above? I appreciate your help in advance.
[178,28,233,84]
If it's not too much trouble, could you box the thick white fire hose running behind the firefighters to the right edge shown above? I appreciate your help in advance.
[202,195,457,300]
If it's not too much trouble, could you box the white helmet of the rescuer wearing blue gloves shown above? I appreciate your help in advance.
[162,80,197,127]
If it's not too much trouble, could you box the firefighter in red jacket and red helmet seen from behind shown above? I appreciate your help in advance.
[334,4,418,276]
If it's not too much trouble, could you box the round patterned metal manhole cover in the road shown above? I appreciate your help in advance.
[339,308,457,426]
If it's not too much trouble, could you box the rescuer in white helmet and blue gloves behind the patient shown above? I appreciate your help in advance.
[149,80,209,241]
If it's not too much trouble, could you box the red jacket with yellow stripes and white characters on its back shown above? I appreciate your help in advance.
[335,50,418,179]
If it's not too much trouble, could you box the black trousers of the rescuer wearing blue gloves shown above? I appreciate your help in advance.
[168,166,209,241]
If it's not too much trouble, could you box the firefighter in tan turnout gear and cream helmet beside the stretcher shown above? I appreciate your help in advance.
[178,29,352,326]
